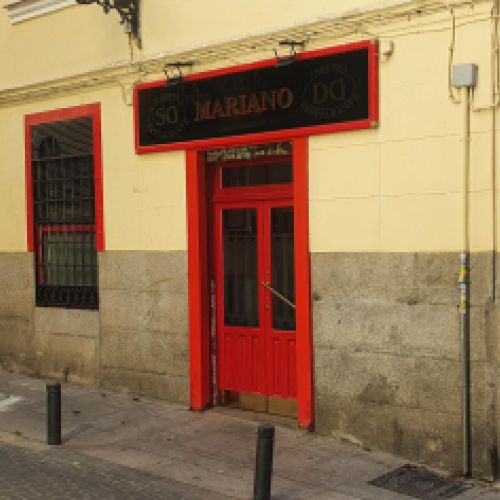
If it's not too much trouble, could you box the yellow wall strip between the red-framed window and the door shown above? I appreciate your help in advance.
[98,89,187,250]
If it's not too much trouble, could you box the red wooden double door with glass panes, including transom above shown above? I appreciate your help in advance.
[211,157,296,398]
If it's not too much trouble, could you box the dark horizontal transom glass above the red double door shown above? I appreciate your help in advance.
[222,162,292,188]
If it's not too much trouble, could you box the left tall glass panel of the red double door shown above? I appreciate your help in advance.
[222,208,259,326]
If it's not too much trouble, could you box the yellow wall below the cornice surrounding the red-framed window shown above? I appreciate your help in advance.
[0,88,186,252]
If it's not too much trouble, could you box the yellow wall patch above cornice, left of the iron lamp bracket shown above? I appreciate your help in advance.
[0,5,129,89]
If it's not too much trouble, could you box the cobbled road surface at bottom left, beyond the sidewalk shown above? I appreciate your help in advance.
[0,443,229,500]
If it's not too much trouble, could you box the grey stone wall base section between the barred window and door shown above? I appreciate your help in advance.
[99,251,189,403]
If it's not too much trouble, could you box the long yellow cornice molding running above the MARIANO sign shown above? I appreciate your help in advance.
[0,0,491,109]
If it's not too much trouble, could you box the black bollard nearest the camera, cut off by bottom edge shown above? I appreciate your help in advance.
[253,424,274,500]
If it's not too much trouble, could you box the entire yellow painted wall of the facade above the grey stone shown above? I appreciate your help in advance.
[0,0,500,252]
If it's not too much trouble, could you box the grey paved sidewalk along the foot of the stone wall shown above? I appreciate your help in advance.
[0,371,500,500]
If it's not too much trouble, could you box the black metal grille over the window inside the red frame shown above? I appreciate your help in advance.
[31,117,99,308]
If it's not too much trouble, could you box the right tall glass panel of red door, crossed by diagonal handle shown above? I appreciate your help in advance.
[271,207,295,330]
